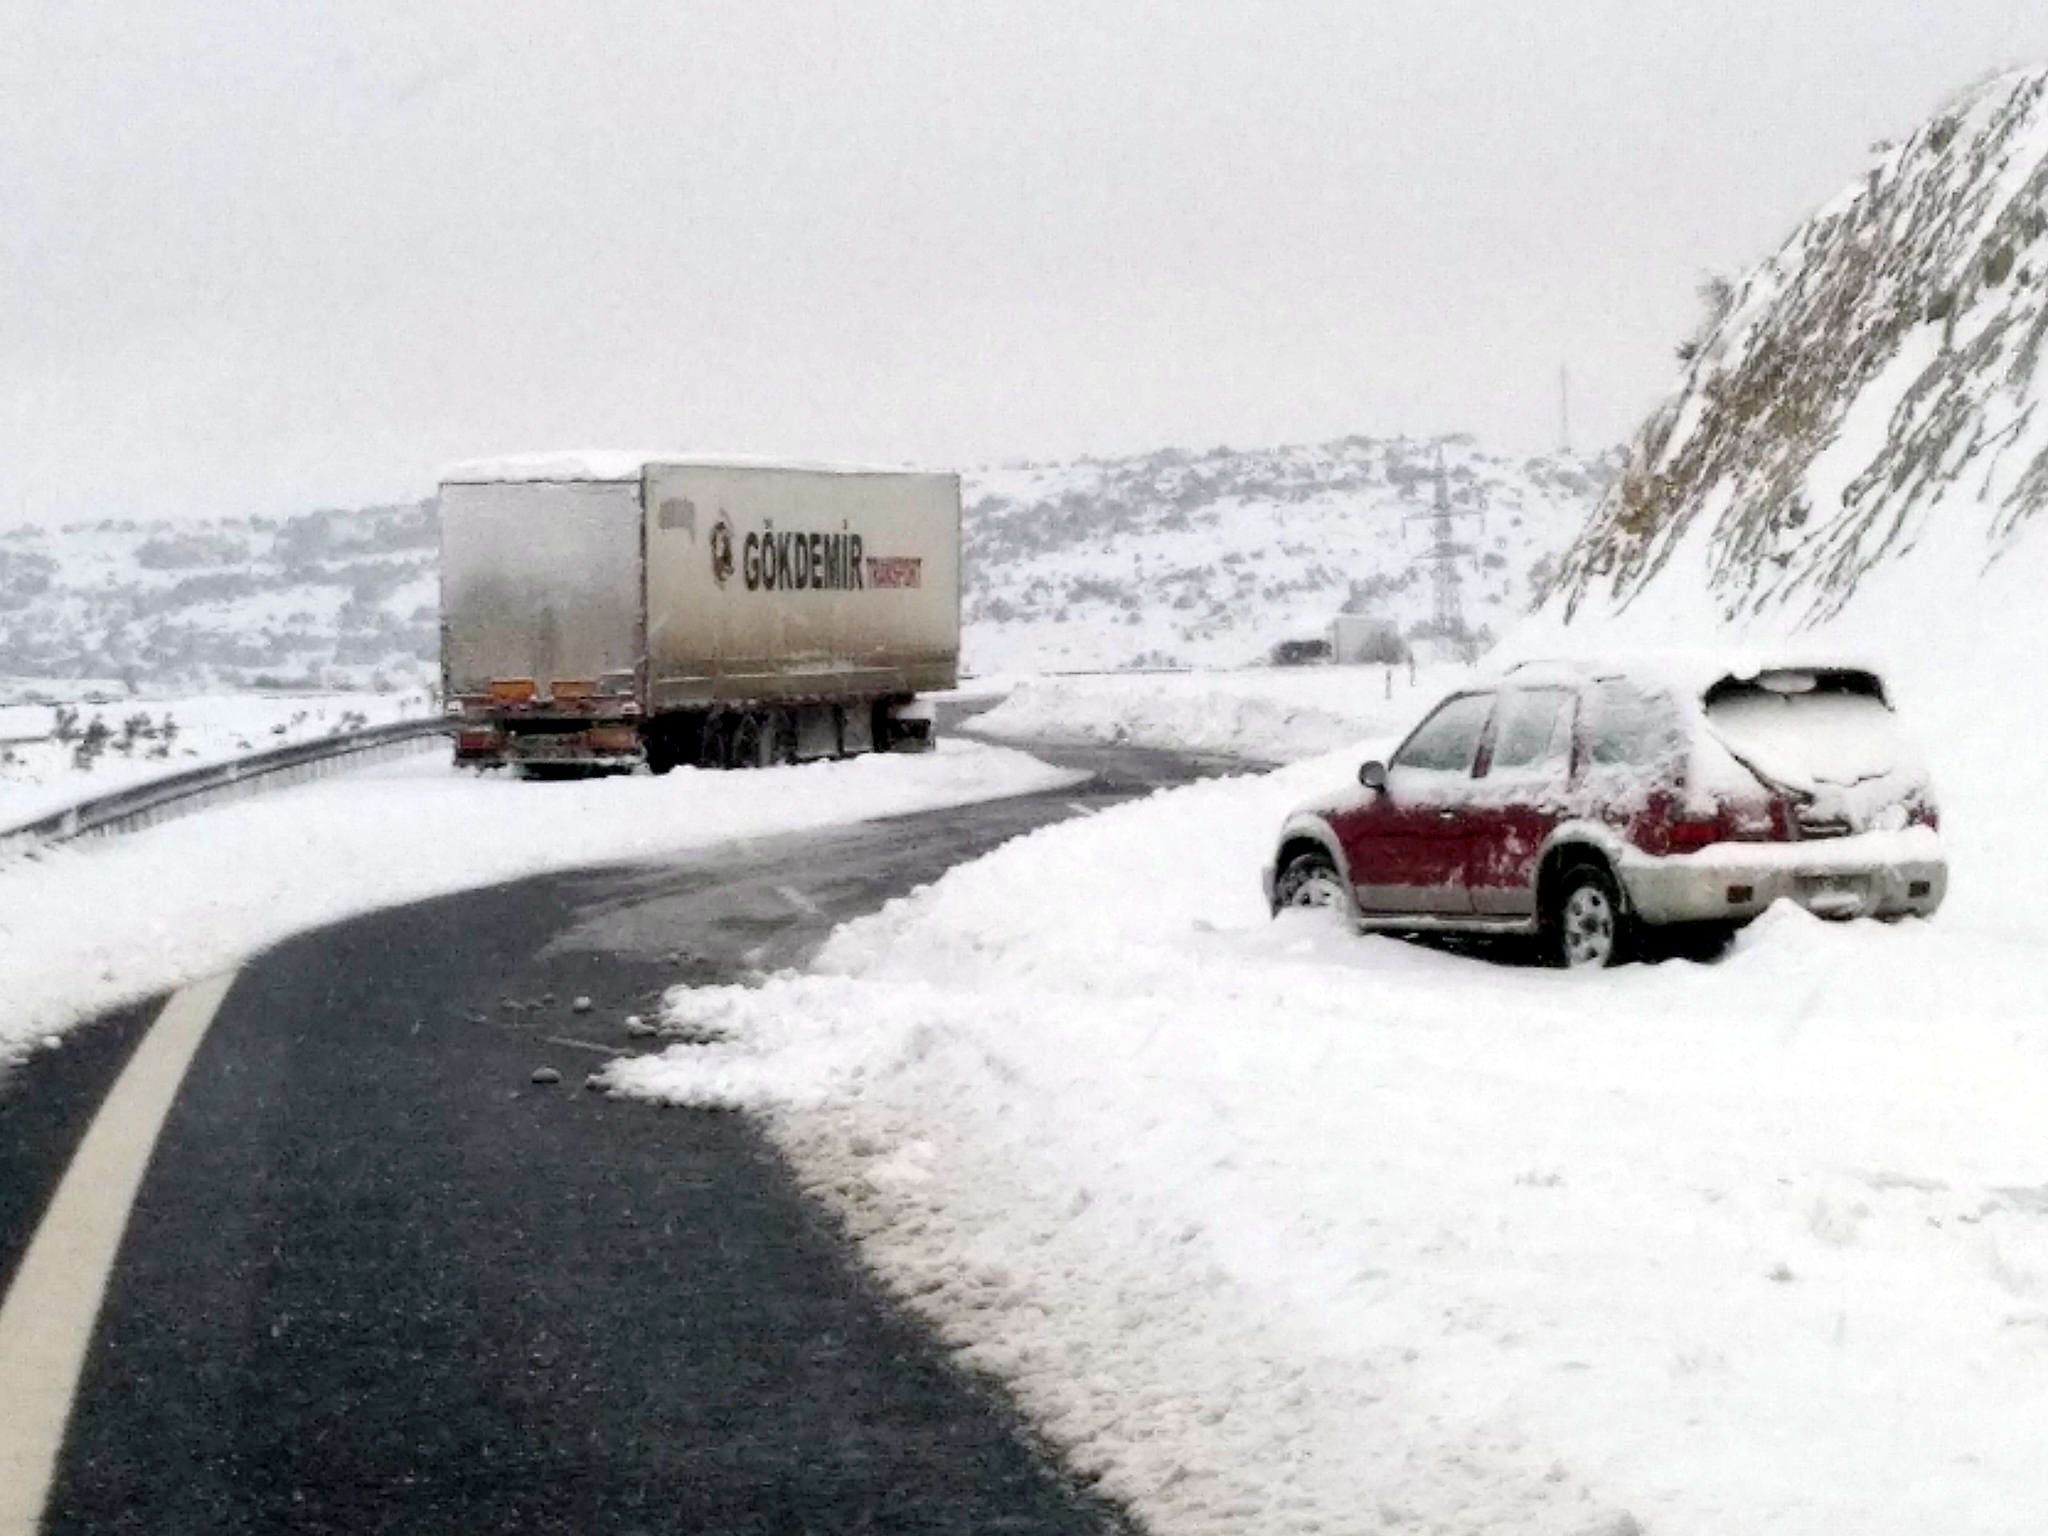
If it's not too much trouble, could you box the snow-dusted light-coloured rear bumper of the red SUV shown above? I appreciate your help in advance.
[1620,827,1948,924]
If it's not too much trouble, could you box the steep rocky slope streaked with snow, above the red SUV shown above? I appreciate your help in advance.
[1550,70,2048,633]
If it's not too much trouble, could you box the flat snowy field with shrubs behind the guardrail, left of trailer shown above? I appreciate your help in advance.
[0,682,430,827]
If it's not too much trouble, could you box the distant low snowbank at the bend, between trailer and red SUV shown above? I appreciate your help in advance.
[967,666,1448,764]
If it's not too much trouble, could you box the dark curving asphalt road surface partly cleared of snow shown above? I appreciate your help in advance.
[0,737,1236,1536]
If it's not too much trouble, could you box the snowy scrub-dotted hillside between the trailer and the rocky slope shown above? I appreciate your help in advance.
[965,436,1612,672]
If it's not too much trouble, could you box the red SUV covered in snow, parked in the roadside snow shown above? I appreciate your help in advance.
[1266,662,1948,967]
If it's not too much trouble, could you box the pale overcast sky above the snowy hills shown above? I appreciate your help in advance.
[0,0,2048,524]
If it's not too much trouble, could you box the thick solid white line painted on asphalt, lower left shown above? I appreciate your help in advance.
[0,971,233,1536]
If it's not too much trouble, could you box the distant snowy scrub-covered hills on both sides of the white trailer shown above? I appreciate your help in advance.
[0,438,1612,692]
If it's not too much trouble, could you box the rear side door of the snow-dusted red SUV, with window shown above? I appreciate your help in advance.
[1464,688,1577,918]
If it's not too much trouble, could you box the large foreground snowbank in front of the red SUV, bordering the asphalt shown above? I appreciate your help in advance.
[606,754,2048,1536]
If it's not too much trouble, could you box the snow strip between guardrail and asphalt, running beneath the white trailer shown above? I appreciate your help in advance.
[0,741,1075,1063]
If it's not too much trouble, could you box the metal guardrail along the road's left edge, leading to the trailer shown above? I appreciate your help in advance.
[0,719,449,858]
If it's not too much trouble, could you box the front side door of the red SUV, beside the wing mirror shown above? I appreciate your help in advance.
[1333,692,1493,915]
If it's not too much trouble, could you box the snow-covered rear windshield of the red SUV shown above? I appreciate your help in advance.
[1704,672,1921,788]
